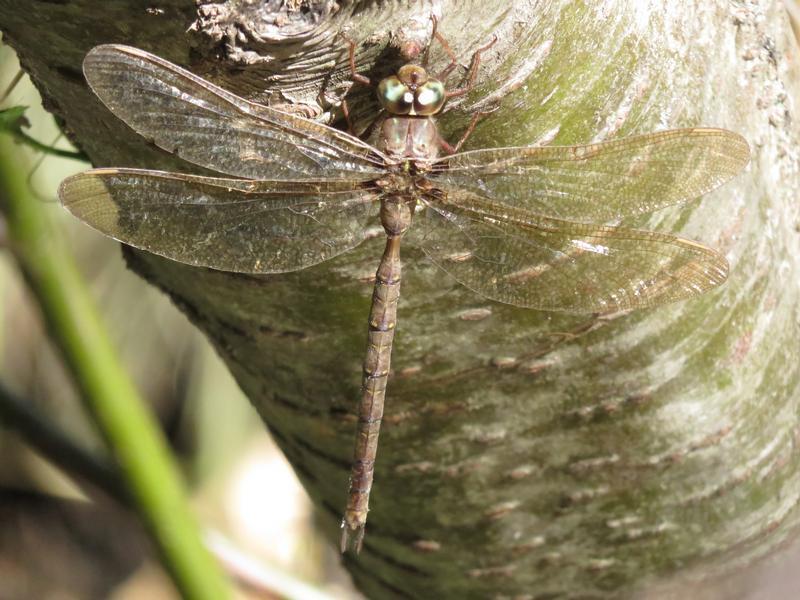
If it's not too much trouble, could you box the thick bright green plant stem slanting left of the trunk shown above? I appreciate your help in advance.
[0,137,230,600]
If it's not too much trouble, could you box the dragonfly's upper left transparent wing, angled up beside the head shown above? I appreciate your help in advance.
[83,45,385,181]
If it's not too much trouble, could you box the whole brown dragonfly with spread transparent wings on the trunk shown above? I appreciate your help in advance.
[59,36,749,552]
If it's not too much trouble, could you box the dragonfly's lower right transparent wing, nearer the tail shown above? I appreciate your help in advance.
[407,192,728,312]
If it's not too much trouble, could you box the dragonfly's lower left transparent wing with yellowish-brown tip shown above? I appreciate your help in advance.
[58,169,377,273]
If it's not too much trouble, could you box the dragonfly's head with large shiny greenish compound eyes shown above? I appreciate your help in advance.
[378,65,446,117]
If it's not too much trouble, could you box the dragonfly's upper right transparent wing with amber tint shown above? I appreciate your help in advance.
[430,129,750,223]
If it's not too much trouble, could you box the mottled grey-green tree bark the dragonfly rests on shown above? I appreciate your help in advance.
[0,0,800,598]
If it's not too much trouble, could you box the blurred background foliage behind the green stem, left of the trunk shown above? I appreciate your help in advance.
[0,41,355,599]
